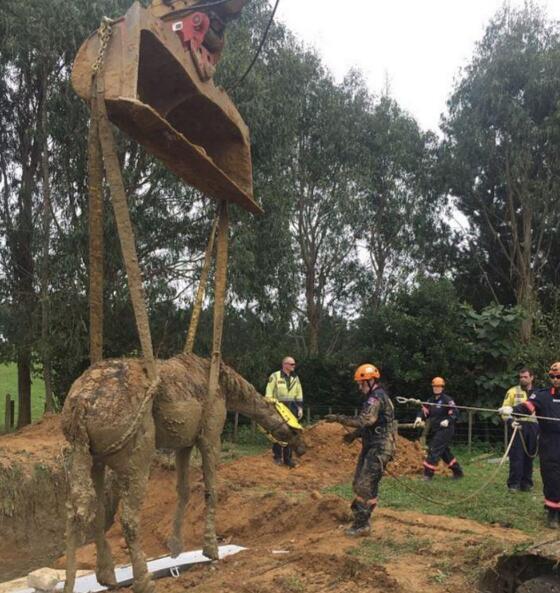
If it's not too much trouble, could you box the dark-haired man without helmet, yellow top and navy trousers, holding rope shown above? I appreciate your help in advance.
[502,368,539,492]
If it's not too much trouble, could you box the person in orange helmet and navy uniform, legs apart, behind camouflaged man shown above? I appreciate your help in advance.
[414,377,464,480]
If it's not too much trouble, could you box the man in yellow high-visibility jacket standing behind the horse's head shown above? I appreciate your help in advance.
[265,356,303,468]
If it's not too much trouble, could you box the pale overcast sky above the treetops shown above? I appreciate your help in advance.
[277,0,560,131]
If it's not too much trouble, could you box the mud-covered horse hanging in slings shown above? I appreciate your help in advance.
[62,354,305,593]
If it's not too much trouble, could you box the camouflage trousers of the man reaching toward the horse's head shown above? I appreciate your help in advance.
[352,437,395,505]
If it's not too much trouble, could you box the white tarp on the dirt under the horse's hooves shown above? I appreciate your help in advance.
[13,545,245,593]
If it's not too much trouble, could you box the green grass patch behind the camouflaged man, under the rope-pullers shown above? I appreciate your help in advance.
[327,447,544,534]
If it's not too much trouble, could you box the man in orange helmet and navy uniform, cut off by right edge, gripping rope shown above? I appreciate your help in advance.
[498,362,560,529]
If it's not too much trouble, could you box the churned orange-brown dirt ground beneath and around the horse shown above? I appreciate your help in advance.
[0,418,526,593]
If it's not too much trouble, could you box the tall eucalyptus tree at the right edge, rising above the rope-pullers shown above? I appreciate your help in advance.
[443,3,560,341]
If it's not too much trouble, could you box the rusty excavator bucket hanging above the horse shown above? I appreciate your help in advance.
[72,0,262,213]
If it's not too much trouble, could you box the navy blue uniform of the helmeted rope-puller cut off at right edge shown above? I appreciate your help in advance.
[513,387,560,511]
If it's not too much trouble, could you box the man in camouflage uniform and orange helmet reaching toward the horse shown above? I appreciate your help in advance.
[325,364,395,537]
